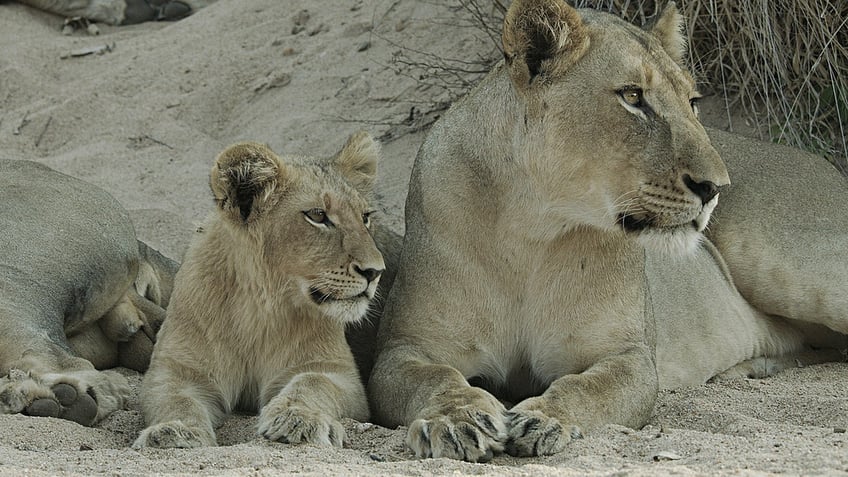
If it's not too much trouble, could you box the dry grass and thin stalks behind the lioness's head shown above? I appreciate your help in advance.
[430,0,848,161]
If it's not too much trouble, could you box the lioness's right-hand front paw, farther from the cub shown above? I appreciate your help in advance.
[506,409,583,457]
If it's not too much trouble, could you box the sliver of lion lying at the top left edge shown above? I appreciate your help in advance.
[17,0,215,25]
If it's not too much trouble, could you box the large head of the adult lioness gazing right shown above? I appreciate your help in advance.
[503,0,730,253]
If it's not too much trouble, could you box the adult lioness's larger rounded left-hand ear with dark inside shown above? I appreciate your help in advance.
[503,0,589,87]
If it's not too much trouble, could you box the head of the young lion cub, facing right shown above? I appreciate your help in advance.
[210,132,385,322]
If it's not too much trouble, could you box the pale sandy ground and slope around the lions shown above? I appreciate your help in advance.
[0,0,848,476]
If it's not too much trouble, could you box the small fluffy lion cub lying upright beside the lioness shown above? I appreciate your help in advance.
[133,132,385,448]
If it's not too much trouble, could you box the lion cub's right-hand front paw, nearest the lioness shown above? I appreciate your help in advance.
[259,406,344,447]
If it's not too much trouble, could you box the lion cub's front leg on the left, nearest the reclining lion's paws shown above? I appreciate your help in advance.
[133,358,222,449]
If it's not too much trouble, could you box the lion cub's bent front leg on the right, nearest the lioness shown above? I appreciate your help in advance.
[258,359,369,447]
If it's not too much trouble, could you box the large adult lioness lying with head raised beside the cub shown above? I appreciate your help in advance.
[368,0,848,461]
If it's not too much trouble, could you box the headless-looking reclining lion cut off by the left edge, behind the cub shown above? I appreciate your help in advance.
[0,160,177,425]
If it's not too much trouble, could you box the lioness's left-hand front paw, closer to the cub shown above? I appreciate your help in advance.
[406,406,506,462]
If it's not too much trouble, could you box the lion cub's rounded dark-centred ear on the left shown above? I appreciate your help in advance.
[209,142,283,224]
